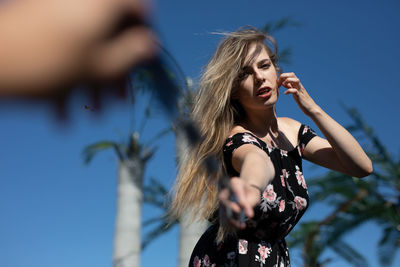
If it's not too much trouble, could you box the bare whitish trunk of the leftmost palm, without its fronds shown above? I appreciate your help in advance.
[113,159,144,267]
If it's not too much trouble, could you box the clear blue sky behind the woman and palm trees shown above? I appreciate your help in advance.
[0,0,400,267]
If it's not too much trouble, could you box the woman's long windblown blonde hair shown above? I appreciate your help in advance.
[170,26,279,239]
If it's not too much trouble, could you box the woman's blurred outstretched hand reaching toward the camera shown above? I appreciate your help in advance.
[218,177,261,229]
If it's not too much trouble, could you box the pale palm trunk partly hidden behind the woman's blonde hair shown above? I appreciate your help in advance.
[175,127,208,267]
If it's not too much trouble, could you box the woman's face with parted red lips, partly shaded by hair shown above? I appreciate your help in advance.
[233,44,279,111]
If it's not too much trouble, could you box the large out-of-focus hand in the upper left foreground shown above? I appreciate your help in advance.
[0,0,156,99]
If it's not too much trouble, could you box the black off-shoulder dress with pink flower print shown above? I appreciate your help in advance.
[189,125,316,267]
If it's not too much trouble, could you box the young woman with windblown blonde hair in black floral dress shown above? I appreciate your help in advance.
[171,28,372,267]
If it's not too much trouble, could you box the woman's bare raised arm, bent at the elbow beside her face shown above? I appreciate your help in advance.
[278,73,373,178]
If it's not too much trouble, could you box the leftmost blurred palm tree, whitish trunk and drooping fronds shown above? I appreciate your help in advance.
[83,71,171,267]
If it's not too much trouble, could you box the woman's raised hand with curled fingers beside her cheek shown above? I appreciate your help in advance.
[278,72,318,115]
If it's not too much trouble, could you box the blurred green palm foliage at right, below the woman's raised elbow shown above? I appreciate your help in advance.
[290,108,400,267]
